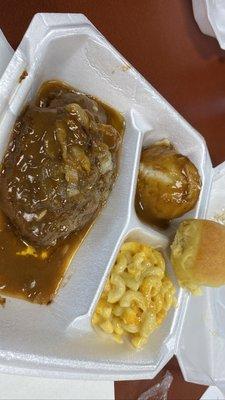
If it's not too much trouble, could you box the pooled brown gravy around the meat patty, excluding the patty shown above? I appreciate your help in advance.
[0,81,124,304]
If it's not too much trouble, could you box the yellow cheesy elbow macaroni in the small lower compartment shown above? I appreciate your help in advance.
[92,242,176,348]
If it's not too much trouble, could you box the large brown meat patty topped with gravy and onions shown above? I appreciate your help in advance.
[0,82,121,246]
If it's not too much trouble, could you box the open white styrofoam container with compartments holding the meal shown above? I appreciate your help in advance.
[0,14,225,383]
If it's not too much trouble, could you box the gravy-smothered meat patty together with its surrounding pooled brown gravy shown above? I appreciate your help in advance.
[0,81,124,303]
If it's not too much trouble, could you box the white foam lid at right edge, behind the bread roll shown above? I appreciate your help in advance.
[177,162,225,394]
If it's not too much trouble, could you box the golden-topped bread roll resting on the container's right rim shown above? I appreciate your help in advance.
[171,219,225,294]
